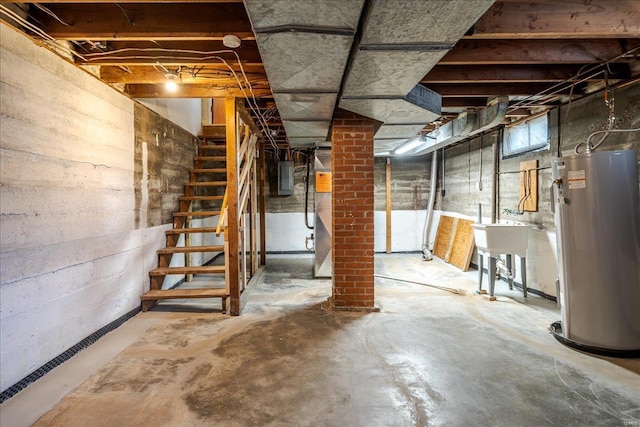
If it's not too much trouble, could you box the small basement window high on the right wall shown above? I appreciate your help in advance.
[502,114,549,159]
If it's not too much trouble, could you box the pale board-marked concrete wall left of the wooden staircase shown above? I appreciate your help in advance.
[0,23,194,390]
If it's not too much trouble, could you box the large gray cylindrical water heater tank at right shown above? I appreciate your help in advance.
[551,150,640,357]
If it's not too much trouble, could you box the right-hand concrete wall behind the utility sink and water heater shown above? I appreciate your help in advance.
[436,83,640,296]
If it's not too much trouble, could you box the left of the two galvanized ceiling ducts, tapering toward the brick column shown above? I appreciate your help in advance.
[244,0,364,147]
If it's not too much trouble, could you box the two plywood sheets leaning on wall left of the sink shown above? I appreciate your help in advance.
[433,215,475,271]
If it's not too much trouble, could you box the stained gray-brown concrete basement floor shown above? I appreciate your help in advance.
[0,254,640,427]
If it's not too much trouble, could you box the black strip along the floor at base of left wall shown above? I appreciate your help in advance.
[0,307,140,403]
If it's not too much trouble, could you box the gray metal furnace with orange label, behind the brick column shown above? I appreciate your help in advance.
[313,148,333,277]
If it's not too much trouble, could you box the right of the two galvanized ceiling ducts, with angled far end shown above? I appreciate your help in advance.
[339,0,494,152]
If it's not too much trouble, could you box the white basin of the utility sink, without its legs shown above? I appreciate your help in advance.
[471,224,529,258]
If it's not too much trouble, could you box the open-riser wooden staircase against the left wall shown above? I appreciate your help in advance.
[141,138,229,313]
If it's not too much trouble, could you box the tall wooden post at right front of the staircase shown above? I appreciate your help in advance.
[225,97,240,316]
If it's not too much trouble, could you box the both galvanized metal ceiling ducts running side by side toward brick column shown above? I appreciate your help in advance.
[244,0,495,152]
